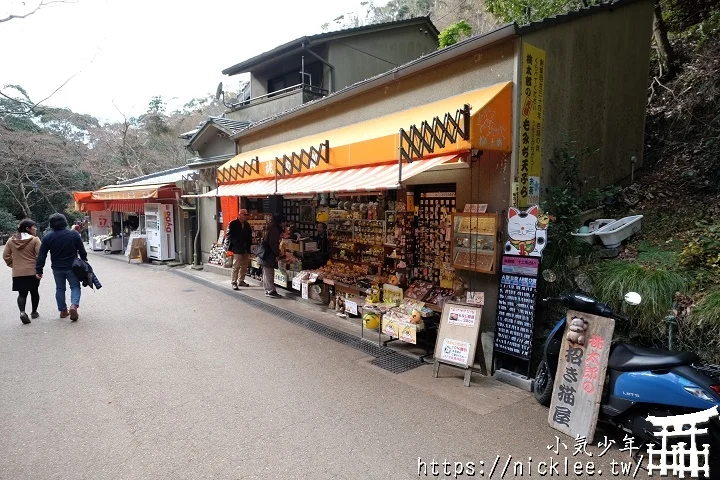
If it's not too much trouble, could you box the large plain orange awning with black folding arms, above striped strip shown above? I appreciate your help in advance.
[218,82,512,184]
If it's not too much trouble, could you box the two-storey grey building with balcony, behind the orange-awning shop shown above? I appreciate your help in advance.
[181,17,439,268]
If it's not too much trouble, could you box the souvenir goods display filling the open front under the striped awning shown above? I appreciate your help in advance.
[276,184,498,355]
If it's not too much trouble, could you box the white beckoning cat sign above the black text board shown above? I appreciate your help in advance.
[505,205,550,257]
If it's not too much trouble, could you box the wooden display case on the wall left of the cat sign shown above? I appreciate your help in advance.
[452,213,498,273]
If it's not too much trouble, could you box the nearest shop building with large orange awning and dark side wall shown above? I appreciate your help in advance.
[190,0,653,372]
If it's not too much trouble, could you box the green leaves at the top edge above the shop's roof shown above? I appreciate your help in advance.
[485,0,600,25]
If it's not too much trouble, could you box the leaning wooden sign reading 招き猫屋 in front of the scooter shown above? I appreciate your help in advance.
[548,310,615,443]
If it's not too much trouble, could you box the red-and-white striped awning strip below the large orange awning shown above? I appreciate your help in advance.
[185,155,458,198]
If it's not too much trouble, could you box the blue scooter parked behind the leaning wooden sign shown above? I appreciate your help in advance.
[534,293,720,479]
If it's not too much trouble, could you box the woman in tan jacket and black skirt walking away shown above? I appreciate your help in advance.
[3,218,40,325]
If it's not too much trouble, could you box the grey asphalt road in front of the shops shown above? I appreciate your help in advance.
[0,251,646,480]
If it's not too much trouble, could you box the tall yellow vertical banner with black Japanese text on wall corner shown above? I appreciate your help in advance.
[518,43,545,207]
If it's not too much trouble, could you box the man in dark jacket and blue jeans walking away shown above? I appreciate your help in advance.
[35,213,87,322]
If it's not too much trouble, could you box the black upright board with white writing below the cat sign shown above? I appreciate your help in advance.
[494,255,540,360]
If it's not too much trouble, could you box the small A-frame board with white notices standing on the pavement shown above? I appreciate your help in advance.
[433,302,485,386]
